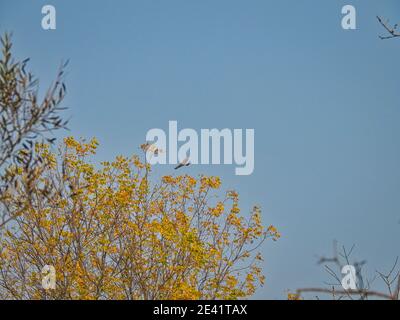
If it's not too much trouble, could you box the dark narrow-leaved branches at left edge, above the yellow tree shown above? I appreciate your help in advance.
[0,34,67,228]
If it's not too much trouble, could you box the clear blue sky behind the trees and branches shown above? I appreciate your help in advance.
[0,0,400,299]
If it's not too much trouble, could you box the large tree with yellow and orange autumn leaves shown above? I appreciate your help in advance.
[0,138,280,299]
